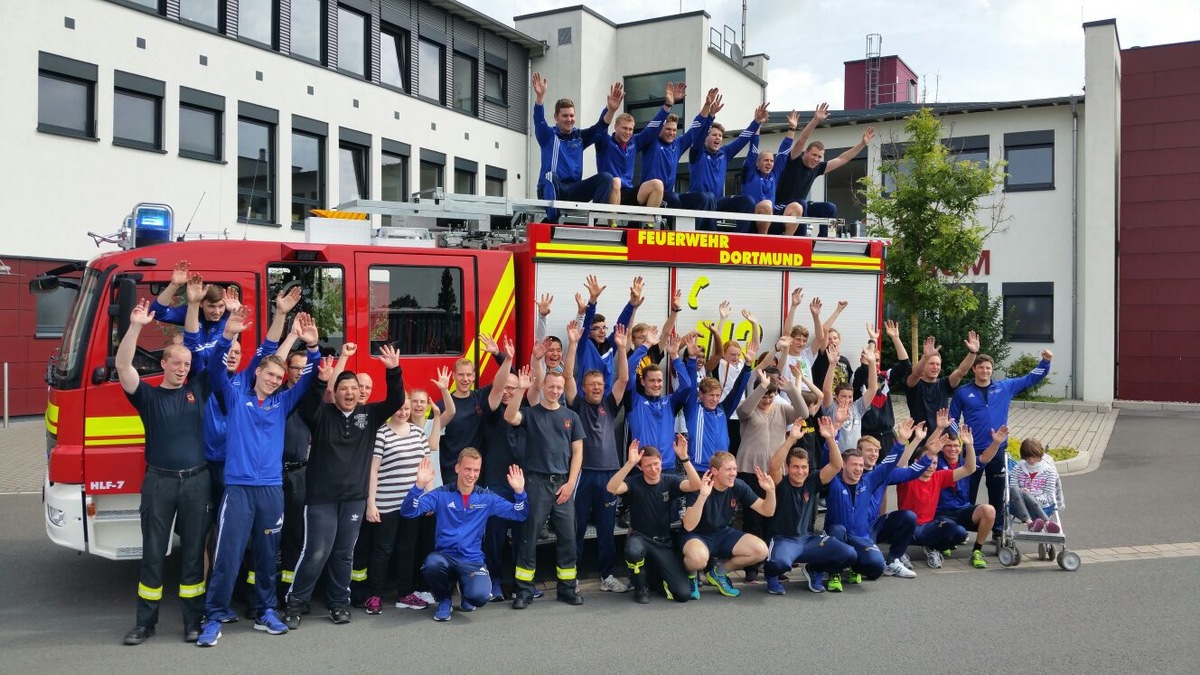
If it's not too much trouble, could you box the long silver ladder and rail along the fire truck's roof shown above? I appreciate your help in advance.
[336,189,862,237]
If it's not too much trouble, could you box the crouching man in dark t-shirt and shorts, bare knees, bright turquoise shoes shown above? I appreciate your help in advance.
[683,452,775,598]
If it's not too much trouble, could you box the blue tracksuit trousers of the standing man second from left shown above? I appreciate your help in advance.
[204,485,283,621]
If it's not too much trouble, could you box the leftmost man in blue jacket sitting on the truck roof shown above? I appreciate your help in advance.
[533,72,624,222]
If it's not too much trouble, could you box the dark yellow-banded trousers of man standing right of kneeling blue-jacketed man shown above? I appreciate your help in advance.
[516,472,577,593]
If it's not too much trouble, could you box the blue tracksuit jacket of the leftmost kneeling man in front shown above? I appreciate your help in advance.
[400,485,529,562]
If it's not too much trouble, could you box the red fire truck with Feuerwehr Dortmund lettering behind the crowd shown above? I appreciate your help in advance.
[31,205,886,560]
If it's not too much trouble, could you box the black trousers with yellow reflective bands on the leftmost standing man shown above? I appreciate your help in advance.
[138,465,212,628]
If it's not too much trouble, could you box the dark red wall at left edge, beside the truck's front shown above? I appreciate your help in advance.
[0,256,79,417]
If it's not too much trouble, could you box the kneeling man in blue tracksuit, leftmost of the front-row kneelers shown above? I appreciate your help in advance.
[400,448,529,621]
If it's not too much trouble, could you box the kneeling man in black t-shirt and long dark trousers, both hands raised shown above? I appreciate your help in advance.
[607,434,700,604]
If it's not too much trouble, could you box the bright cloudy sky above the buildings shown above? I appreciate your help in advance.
[461,0,1200,109]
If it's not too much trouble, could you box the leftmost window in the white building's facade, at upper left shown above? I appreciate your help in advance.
[37,52,96,139]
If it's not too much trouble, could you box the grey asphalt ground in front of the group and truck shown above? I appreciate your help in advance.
[0,413,1200,674]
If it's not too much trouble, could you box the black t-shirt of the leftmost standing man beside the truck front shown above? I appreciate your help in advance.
[126,377,209,471]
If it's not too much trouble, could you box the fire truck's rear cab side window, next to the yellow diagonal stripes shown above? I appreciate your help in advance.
[367,265,463,356]
